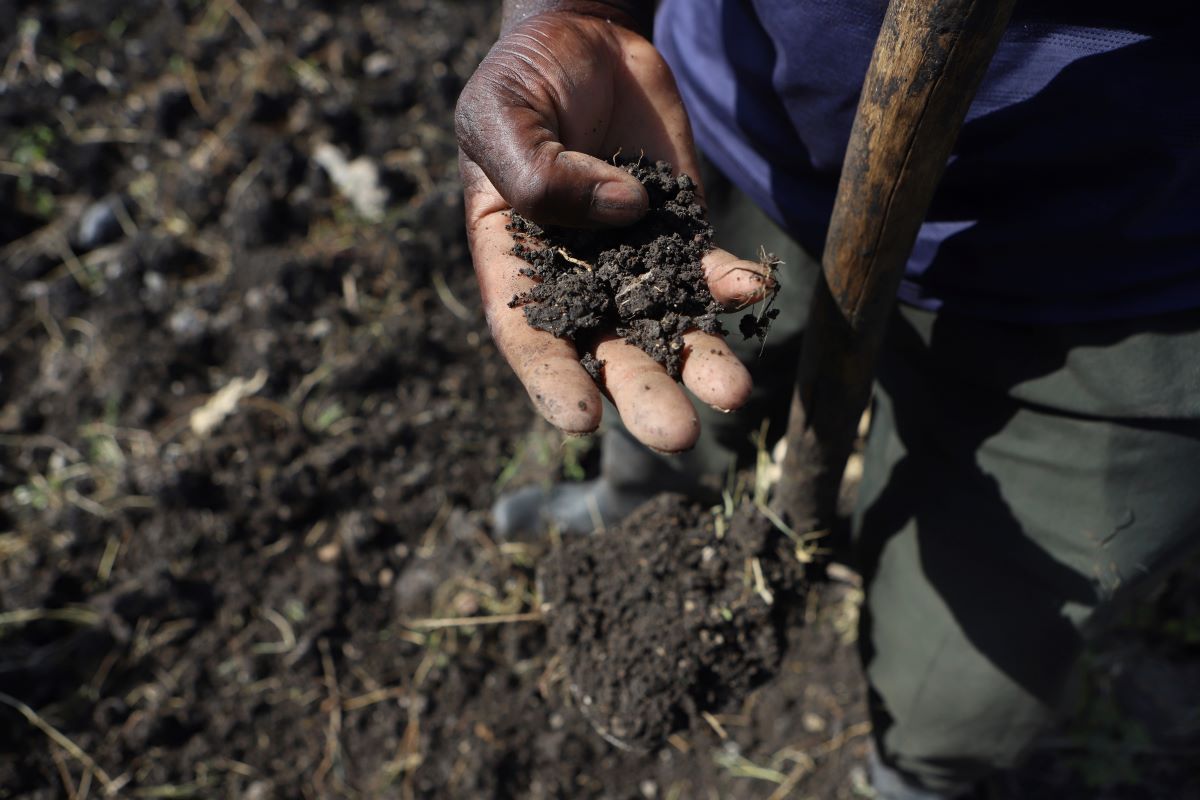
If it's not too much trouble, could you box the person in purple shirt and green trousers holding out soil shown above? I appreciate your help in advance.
[456,0,1200,798]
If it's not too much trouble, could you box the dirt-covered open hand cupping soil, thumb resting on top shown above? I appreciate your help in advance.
[456,2,764,452]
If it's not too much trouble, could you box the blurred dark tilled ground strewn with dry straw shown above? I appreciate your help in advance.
[0,0,1200,800]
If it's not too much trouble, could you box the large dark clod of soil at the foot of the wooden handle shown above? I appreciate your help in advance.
[539,494,803,750]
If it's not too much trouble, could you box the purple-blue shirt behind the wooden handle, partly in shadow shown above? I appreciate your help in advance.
[655,0,1200,323]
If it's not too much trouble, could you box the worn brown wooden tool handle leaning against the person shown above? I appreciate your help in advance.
[775,0,1015,533]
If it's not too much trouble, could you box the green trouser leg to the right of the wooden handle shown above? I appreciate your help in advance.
[856,304,1200,793]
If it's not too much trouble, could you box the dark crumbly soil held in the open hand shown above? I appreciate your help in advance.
[508,161,778,380]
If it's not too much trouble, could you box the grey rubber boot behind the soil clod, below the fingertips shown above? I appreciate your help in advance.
[492,429,713,540]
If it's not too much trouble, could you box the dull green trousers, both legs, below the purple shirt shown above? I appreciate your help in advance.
[609,165,1200,793]
